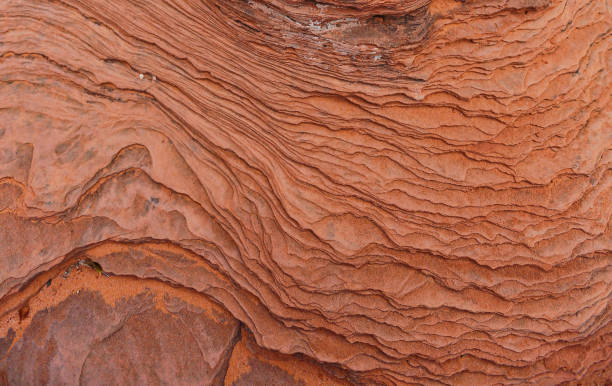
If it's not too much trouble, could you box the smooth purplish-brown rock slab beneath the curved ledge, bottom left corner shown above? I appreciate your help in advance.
[0,273,239,385]
